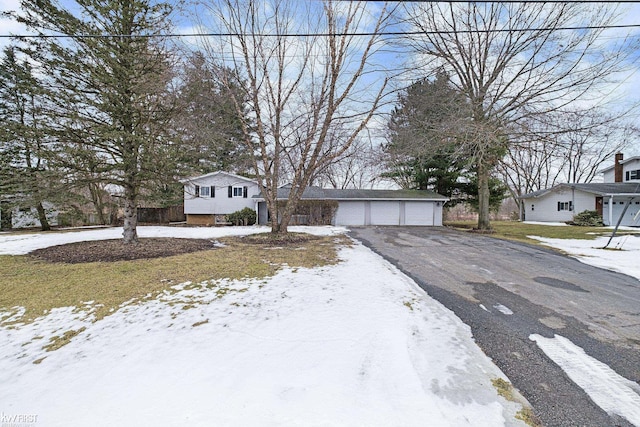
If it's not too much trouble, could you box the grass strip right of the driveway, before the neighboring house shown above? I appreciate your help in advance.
[445,221,640,245]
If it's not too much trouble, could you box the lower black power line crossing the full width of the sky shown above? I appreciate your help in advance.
[0,24,640,39]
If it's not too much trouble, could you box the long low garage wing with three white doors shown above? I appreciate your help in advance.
[255,187,448,226]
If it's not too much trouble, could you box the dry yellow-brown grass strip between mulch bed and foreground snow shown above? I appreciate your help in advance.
[0,237,348,323]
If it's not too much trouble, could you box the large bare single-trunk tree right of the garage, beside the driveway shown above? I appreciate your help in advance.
[406,2,632,229]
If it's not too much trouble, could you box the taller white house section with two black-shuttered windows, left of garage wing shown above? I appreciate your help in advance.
[181,171,260,225]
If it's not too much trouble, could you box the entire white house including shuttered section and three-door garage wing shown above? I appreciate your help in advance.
[182,171,448,226]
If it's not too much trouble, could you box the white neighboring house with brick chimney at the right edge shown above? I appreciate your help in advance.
[520,153,640,226]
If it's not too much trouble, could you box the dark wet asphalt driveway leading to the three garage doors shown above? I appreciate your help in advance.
[351,227,640,427]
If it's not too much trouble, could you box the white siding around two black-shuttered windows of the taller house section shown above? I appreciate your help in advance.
[184,173,260,215]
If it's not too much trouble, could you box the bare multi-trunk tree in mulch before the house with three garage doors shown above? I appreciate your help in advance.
[198,0,390,233]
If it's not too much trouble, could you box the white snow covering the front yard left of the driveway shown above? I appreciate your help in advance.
[0,227,524,427]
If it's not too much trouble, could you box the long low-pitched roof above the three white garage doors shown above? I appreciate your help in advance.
[253,187,449,202]
